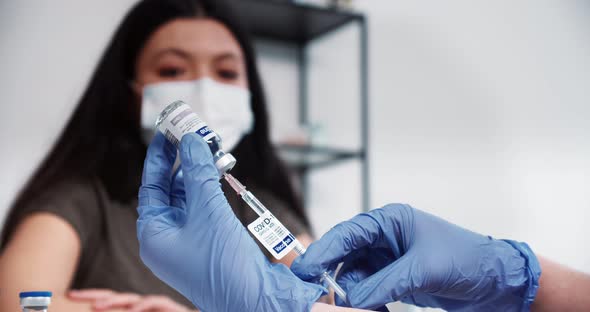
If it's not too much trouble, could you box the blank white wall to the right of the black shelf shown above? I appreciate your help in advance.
[358,0,590,272]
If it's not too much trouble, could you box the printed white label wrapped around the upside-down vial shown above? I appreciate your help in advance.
[158,103,215,146]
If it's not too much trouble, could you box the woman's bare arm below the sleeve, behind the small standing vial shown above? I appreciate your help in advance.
[0,212,122,312]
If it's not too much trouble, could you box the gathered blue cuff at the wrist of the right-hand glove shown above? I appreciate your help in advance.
[503,239,541,312]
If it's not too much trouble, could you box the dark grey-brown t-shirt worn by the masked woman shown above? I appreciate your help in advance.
[4,180,307,307]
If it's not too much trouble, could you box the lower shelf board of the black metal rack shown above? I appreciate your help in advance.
[277,144,364,172]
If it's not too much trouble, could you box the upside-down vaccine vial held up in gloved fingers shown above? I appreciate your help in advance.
[156,101,236,176]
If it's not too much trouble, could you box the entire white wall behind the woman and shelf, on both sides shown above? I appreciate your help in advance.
[0,0,590,308]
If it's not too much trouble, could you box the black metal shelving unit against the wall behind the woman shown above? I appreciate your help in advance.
[229,0,370,211]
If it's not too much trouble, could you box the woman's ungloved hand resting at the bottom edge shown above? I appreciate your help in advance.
[68,289,195,312]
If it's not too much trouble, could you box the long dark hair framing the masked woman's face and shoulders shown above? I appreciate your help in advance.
[3,0,308,241]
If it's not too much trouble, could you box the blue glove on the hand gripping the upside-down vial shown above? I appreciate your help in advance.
[137,133,325,311]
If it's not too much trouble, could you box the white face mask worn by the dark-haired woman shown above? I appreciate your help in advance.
[141,78,254,152]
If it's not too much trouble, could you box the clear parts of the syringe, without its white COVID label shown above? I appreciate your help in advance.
[223,172,347,302]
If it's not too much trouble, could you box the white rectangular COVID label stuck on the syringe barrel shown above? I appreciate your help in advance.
[248,211,297,260]
